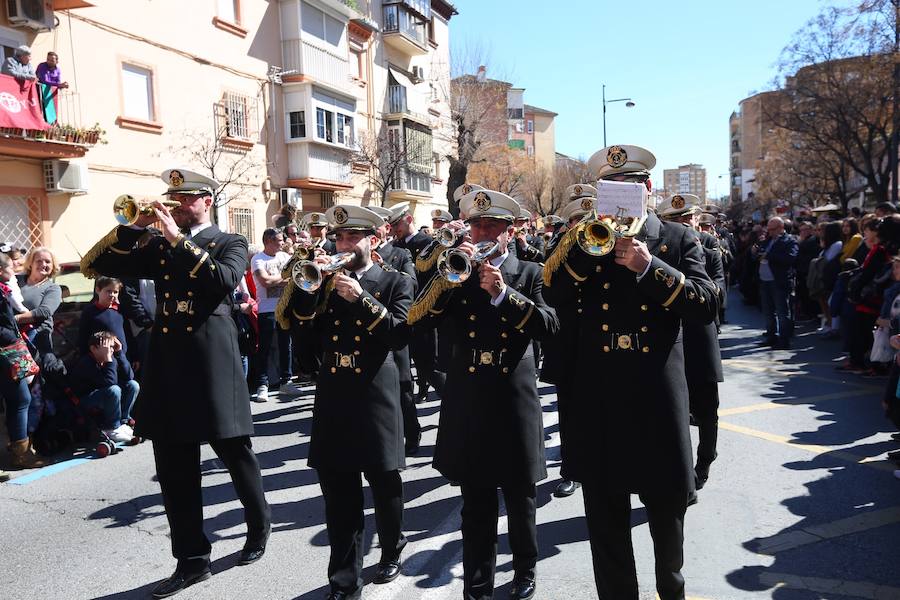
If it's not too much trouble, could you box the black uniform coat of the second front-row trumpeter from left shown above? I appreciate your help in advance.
[276,265,413,472]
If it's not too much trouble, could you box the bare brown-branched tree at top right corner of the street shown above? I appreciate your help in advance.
[769,0,897,208]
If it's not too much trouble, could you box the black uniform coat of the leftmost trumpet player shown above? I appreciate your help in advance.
[81,225,253,443]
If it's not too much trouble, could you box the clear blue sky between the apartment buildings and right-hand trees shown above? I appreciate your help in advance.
[450,0,837,200]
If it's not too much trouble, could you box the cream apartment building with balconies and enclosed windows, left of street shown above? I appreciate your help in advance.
[0,0,456,261]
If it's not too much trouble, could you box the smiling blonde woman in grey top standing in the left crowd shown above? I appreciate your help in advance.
[16,247,62,354]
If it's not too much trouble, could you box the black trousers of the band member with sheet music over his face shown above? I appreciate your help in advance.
[582,480,687,600]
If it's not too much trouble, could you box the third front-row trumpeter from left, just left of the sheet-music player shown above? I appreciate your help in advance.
[409,190,557,600]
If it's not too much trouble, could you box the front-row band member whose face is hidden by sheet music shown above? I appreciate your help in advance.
[544,146,718,600]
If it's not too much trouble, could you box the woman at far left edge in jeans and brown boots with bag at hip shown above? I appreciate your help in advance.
[0,254,43,472]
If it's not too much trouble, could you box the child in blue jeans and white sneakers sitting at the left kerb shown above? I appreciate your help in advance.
[69,331,140,442]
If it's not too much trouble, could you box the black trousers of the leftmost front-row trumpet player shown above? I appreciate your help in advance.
[153,435,272,563]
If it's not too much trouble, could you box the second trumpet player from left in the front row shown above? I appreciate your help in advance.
[277,205,413,600]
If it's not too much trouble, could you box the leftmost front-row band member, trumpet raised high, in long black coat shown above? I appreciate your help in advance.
[81,169,271,598]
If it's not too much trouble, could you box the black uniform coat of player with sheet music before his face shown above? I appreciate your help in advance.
[544,214,718,492]
